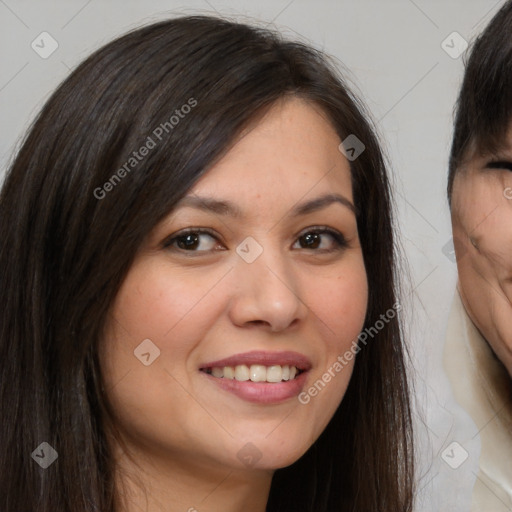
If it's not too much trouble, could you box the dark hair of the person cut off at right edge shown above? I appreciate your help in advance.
[448,1,512,199]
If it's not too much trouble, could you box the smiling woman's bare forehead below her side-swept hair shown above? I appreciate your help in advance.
[192,97,352,202]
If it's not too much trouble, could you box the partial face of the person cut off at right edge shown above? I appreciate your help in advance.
[452,130,512,375]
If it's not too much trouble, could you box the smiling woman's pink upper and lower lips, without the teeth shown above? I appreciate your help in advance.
[200,351,311,404]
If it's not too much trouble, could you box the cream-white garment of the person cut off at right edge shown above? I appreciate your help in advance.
[444,293,512,512]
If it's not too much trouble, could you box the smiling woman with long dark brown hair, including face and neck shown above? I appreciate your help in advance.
[0,16,412,512]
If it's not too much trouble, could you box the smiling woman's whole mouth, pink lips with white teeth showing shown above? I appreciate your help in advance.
[200,351,311,403]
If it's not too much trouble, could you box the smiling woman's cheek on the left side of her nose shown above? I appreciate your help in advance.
[101,264,230,396]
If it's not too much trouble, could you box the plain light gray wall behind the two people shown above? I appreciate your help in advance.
[0,0,503,512]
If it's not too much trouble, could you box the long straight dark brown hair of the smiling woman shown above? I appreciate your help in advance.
[0,16,413,512]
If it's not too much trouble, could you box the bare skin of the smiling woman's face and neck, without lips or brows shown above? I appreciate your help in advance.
[100,98,368,512]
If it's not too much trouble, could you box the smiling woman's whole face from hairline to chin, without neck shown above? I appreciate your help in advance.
[100,98,368,476]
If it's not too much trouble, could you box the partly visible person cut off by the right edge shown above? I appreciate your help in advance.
[445,2,512,512]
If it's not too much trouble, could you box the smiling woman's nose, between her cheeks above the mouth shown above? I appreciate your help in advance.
[229,250,308,332]
